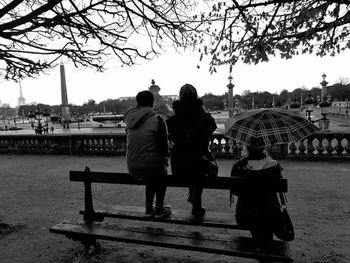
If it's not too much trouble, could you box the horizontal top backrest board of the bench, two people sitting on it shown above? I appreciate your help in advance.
[69,171,288,193]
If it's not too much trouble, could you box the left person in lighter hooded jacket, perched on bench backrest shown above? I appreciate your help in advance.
[124,90,171,218]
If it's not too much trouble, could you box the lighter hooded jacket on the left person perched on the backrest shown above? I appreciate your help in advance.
[124,106,168,182]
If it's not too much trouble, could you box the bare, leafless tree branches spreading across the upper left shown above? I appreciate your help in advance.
[0,0,199,79]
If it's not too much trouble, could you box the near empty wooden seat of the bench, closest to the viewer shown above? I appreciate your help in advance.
[50,219,293,262]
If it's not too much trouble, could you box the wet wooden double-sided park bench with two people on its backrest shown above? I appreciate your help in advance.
[49,168,293,262]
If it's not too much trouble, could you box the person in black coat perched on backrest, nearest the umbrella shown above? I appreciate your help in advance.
[166,84,216,216]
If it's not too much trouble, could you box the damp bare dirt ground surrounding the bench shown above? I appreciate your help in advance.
[0,155,350,263]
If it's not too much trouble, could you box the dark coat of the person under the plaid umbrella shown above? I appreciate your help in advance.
[231,157,282,227]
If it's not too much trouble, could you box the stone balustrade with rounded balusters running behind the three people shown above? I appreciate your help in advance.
[0,132,350,160]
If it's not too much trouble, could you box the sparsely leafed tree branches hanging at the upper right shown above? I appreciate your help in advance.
[197,0,350,71]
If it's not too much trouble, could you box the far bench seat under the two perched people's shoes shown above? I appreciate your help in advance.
[80,205,248,230]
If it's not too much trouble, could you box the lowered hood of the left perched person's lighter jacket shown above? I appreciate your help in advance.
[124,106,155,129]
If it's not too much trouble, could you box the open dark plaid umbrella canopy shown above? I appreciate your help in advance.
[225,110,319,148]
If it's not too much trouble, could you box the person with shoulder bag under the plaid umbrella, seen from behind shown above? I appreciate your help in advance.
[230,145,283,240]
